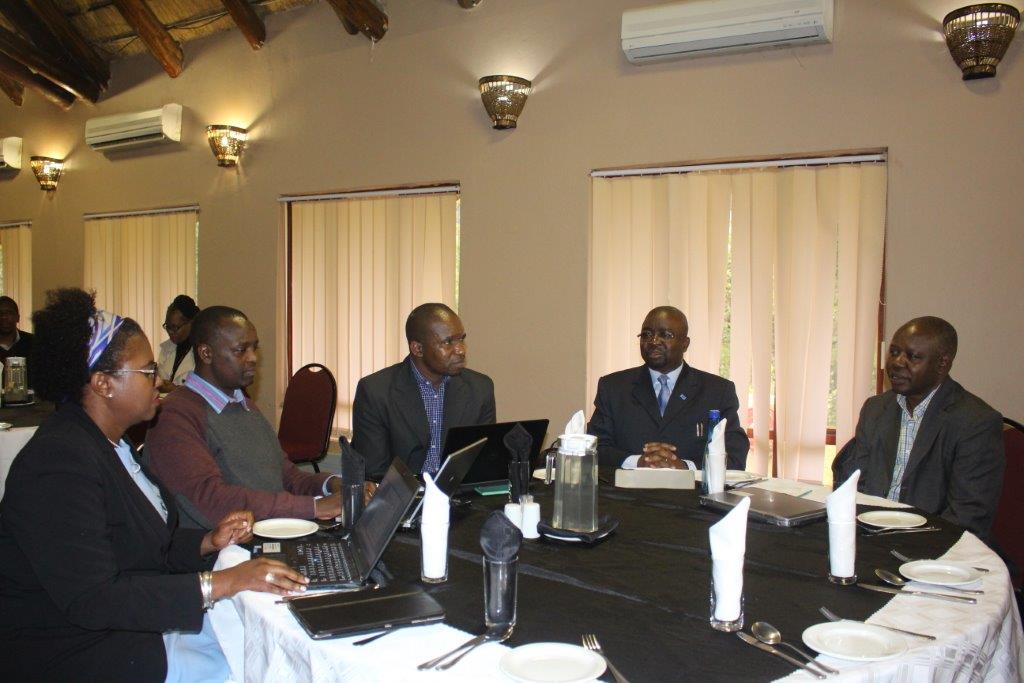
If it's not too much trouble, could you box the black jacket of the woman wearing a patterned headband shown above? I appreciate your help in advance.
[0,404,214,681]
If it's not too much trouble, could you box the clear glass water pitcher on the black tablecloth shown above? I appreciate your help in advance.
[544,434,597,532]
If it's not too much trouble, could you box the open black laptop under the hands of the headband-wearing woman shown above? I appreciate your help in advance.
[253,458,420,589]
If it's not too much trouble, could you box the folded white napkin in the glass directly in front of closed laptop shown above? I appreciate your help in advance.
[708,498,751,622]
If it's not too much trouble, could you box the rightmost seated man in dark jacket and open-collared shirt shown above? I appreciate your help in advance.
[833,315,1006,539]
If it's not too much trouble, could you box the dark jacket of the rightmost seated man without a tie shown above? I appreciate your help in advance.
[833,378,1006,539]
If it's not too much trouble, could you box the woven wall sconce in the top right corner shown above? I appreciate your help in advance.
[942,2,1021,81]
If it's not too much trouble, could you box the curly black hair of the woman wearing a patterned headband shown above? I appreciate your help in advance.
[29,288,143,403]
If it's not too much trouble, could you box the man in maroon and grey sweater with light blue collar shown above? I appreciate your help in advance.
[144,306,341,528]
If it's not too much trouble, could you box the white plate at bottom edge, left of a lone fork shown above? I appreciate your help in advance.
[498,643,605,683]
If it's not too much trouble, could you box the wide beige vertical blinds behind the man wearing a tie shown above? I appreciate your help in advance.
[587,162,886,481]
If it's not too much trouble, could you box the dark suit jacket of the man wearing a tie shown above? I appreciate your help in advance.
[587,365,751,470]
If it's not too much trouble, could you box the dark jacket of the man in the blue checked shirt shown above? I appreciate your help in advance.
[352,355,495,479]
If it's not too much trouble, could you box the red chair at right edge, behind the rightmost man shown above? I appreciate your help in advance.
[992,418,1024,596]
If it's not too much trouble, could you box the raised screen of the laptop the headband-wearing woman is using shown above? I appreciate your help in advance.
[352,458,420,578]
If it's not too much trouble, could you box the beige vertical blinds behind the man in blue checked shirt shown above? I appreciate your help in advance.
[288,187,459,429]
